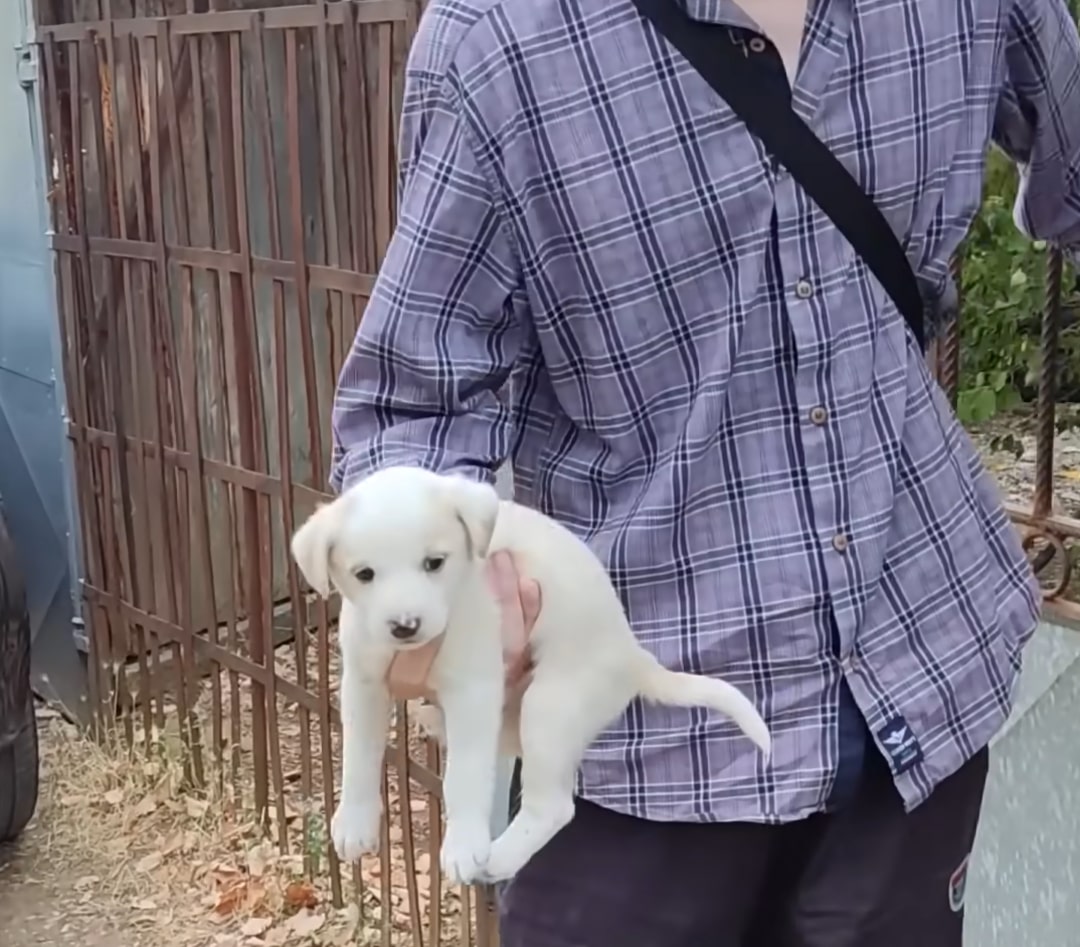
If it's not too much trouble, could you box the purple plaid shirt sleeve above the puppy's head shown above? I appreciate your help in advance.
[330,70,521,490]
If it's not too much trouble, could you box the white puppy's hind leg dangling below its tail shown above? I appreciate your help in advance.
[484,674,623,882]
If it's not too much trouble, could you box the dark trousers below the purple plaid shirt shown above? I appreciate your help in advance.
[500,748,988,947]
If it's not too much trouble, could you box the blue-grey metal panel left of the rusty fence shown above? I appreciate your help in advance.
[0,2,86,717]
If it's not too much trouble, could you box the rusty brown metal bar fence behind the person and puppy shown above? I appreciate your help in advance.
[35,0,1080,947]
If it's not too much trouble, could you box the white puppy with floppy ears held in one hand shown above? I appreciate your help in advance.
[292,468,770,882]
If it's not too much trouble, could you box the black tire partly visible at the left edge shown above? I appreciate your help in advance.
[0,503,39,841]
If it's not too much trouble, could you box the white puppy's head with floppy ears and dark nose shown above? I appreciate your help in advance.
[292,466,499,650]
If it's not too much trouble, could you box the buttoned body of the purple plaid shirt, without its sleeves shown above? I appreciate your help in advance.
[410,0,1036,821]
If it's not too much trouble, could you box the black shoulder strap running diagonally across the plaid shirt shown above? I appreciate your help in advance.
[634,0,924,348]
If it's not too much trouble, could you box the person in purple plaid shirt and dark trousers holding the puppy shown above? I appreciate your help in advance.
[334,0,1080,947]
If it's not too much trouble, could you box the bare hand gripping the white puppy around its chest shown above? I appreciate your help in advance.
[387,551,540,705]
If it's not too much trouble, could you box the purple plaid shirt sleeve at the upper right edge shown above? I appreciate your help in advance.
[994,0,1080,257]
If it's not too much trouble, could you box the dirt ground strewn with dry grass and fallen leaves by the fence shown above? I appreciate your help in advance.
[0,707,472,947]
